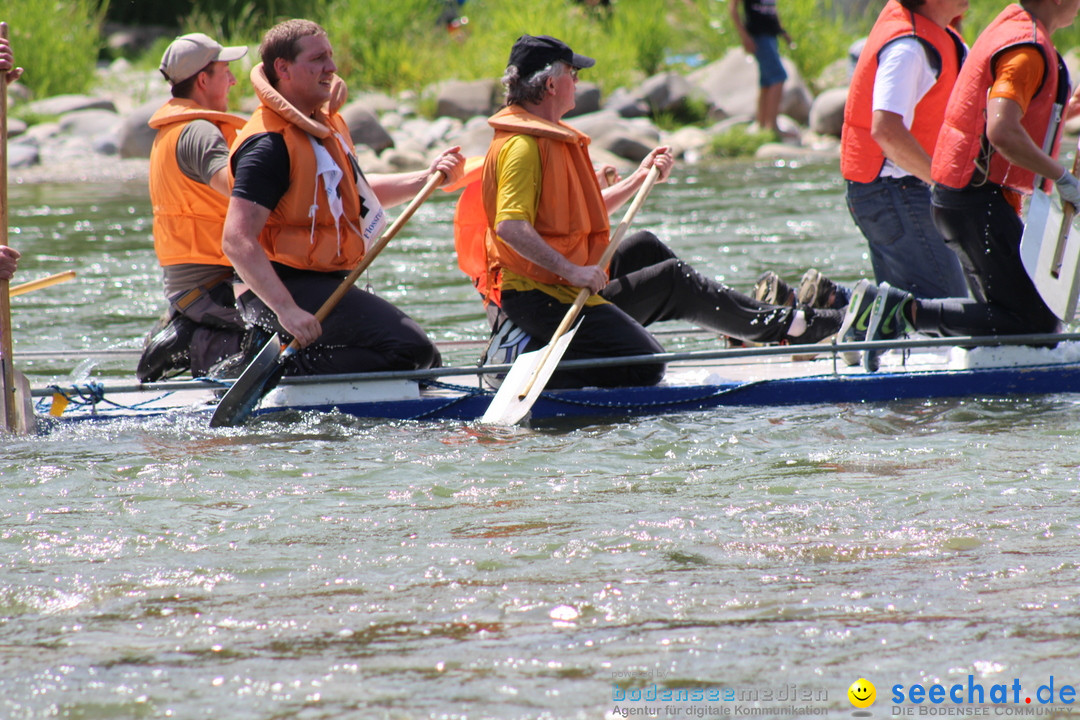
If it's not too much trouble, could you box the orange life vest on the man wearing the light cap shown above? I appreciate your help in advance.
[148,97,244,267]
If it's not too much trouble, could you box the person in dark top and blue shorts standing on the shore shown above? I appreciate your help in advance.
[728,0,792,137]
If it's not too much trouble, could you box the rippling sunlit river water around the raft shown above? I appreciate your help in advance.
[0,162,1080,720]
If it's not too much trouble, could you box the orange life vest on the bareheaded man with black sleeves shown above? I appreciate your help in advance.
[232,64,364,272]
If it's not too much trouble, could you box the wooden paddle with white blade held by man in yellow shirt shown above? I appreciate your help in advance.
[481,165,660,425]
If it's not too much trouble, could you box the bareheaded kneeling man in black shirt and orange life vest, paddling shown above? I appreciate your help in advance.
[222,19,464,375]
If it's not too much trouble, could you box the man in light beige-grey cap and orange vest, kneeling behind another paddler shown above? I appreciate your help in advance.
[136,32,247,382]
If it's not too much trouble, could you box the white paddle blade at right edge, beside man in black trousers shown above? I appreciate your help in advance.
[1021,191,1080,323]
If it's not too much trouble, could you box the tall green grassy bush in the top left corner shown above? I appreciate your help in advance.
[0,0,108,97]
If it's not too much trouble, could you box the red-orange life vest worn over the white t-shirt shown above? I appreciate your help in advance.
[840,0,967,182]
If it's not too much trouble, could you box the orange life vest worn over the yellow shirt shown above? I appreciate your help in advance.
[481,105,610,285]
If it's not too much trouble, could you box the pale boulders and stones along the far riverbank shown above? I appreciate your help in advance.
[9,49,868,182]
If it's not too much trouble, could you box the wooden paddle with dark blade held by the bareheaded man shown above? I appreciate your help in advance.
[210,172,445,427]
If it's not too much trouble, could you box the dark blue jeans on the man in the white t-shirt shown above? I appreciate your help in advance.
[847,176,968,298]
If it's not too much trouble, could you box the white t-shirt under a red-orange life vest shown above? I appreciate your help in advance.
[873,38,937,177]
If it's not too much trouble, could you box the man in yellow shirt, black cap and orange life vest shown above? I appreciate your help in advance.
[481,35,842,386]
